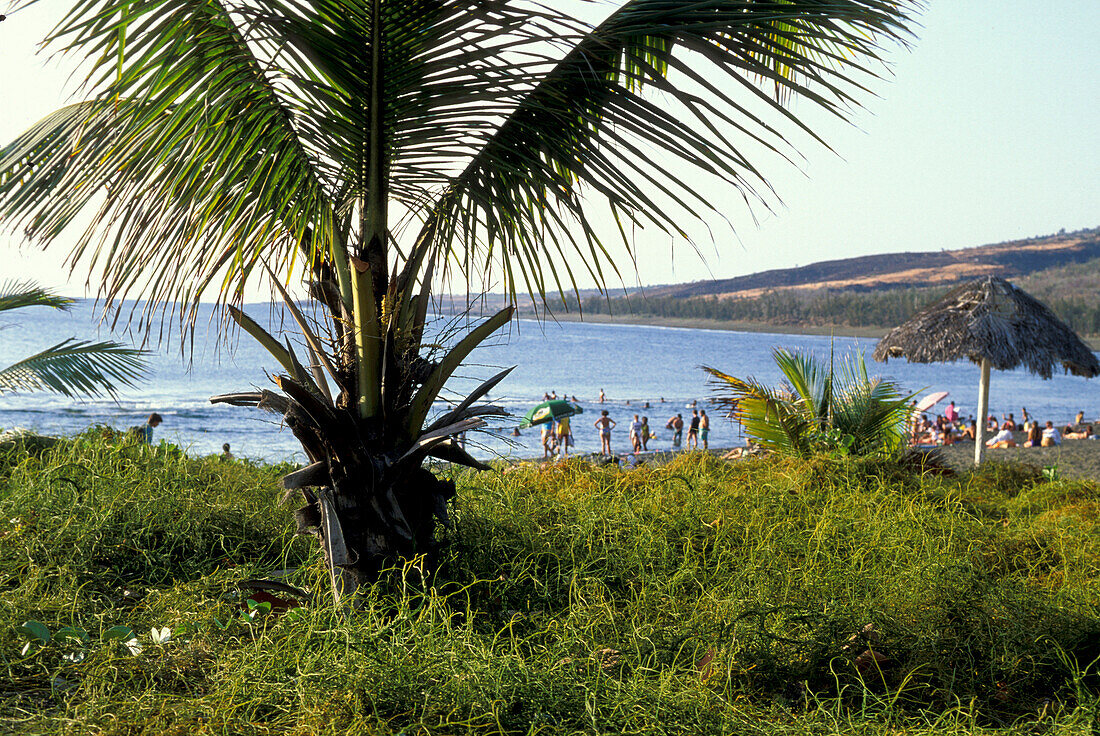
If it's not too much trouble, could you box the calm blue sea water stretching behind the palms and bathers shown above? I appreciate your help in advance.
[0,301,1100,462]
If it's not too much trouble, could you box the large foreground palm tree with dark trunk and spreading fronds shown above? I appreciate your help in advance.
[0,0,910,595]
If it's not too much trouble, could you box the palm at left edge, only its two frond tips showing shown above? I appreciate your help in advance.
[0,281,146,397]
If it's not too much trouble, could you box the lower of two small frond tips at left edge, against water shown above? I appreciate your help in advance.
[0,338,147,397]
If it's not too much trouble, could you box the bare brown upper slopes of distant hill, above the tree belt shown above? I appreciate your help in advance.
[645,228,1100,298]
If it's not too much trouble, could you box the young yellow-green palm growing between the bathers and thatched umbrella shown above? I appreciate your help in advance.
[703,348,912,457]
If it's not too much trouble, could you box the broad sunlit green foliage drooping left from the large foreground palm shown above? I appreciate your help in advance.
[0,0,333,323]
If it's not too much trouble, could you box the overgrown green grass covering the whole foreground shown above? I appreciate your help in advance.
[0,433,1100,734]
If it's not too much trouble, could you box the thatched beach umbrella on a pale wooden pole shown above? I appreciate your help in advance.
[875,276,1100,464]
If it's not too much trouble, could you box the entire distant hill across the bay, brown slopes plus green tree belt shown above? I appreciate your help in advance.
[554,228,1100,343]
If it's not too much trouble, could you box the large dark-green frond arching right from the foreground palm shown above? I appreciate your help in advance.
[433,0,910,301]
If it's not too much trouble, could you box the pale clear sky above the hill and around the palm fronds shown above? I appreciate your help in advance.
[0,0,1100,296]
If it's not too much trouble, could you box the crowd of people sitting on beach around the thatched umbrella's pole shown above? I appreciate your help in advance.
[906,400,1100,448]
